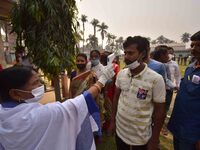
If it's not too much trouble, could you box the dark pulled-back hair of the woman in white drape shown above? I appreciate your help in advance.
[0,66,33,101]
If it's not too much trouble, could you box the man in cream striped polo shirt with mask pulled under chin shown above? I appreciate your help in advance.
[109,36,166,150]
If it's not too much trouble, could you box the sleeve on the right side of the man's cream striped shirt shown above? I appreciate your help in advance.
[153,76,166,103]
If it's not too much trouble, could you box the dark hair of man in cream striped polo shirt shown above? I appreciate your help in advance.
[123,36,150,59]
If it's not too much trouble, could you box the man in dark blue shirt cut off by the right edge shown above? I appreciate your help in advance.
[168,31,200,150]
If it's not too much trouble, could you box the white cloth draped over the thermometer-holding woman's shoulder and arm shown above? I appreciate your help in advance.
[0,95,98,150]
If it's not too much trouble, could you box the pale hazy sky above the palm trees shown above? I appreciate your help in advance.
[77,0,200,42]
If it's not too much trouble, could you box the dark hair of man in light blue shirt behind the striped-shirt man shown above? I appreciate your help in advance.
[153,45,168,61]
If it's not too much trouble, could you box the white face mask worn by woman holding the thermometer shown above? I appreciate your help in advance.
[25,85,44,103]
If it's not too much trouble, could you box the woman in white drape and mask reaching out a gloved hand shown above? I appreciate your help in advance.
[0,67,114,150]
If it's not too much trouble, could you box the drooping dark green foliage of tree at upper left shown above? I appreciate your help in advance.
[10,0,80,77]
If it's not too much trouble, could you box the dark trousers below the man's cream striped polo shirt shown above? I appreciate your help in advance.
[115,134,147,150]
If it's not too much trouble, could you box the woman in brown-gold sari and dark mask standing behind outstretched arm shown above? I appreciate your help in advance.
[70,53,97,98]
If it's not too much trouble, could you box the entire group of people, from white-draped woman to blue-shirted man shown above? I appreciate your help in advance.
[0,31,200,150]
